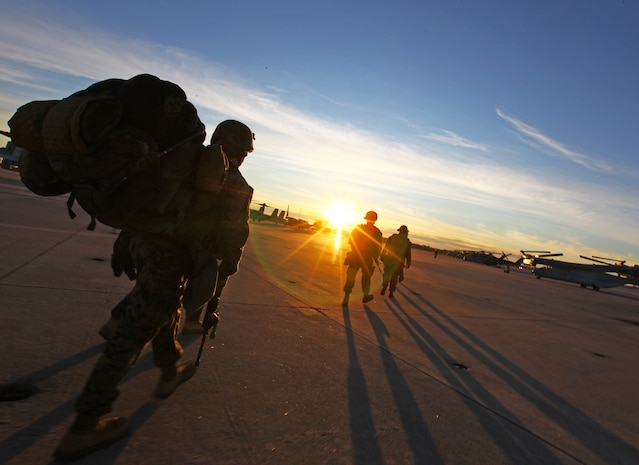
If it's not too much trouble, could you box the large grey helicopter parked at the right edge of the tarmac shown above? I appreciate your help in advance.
[521,250,639,291]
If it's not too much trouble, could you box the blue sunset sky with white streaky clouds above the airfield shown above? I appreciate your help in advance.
[0,0,639,264]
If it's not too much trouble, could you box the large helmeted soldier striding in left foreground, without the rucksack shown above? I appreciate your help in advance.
[55,120,254,461]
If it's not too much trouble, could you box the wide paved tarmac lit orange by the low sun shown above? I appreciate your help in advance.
[0,170,639,465]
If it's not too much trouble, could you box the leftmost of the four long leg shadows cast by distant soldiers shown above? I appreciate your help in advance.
[342,306,384,465]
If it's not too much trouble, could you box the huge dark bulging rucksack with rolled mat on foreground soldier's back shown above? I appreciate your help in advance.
[9,74,227,233]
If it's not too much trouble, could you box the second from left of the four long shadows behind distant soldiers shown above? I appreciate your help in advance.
[364,305,444,465]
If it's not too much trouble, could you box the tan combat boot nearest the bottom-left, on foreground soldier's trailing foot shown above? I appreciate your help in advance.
[54,415,131,462]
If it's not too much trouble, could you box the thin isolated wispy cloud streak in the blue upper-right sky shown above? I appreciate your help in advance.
[495,108,612,173]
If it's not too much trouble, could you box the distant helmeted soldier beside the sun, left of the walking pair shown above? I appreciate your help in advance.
[342,211,382,306]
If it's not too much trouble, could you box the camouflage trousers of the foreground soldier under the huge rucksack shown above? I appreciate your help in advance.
[75,235,186,416]
